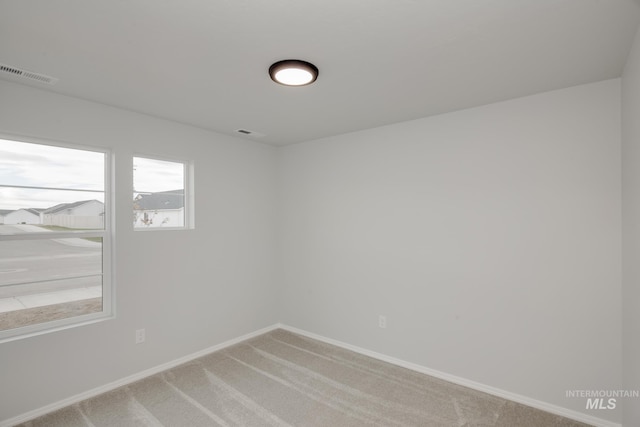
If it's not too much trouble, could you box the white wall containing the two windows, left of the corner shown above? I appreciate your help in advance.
[0,81,278,421]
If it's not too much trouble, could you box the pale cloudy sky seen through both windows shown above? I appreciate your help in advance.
[0,139,184,210]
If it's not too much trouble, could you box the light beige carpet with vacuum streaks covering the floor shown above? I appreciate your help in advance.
[17,330,585,427]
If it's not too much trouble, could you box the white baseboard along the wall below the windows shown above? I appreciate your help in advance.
[0,324,280,427]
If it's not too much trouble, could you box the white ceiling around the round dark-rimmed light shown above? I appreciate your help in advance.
[0,0,640,145]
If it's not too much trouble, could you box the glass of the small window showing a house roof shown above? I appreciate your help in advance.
[133,157,186,229]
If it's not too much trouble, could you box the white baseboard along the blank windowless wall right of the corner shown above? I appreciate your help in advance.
[278,324,622,427]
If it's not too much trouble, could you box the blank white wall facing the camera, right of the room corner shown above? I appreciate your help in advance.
[280,79,621,421]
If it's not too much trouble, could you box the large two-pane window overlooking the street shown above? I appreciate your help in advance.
[0,135,112,341]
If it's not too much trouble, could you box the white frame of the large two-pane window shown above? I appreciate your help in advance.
[0,133,115,343]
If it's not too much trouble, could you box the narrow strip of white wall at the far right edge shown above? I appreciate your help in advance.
[622,25,640,426]
